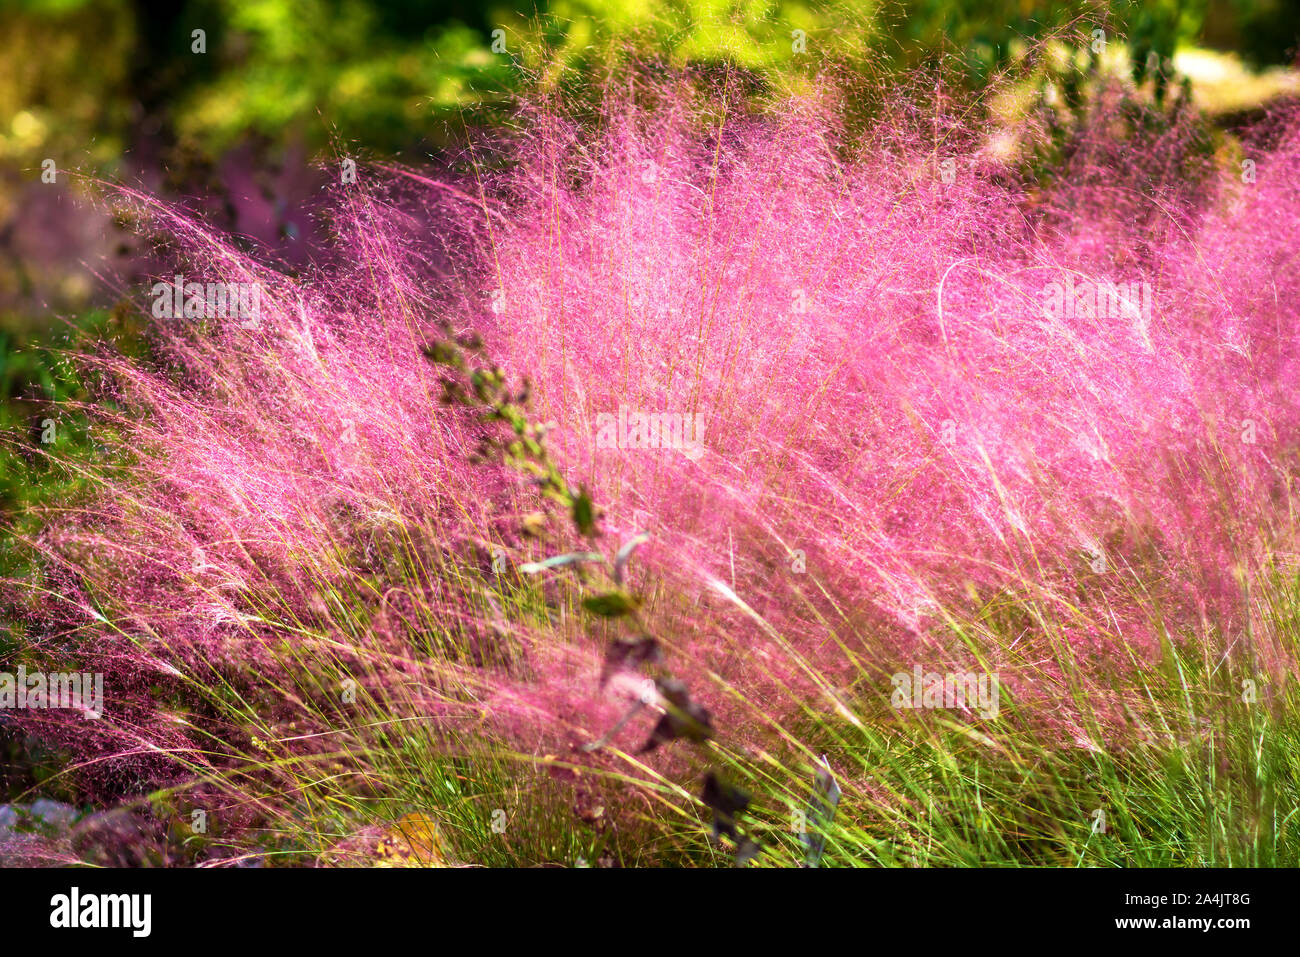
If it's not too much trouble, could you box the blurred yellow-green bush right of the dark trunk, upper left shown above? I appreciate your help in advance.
[169,0,516,152]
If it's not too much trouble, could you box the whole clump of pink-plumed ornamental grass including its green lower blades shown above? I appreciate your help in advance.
[2,63,1300,866]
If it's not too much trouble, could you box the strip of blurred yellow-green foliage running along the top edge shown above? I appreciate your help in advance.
[0,0,1300,174]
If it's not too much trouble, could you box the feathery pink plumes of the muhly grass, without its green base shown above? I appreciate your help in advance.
[7,70,1300,847]
